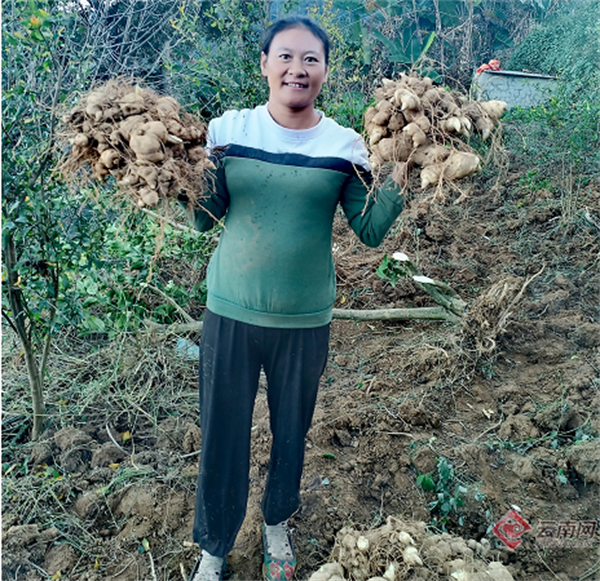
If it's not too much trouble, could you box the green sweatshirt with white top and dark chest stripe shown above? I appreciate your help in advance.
[194,106,403,328]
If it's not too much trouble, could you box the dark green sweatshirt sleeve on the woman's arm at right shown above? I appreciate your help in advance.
[340,172,404,247]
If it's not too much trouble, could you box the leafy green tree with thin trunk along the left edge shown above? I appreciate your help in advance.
[2,0,204,439]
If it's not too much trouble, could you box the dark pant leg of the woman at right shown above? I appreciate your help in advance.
[262,325,329,525]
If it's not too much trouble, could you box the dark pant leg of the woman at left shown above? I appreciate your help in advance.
[194,311,261,557]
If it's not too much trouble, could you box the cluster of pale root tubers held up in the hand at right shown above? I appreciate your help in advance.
[365,74,506,189]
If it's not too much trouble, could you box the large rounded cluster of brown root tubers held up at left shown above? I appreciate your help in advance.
[61,80,214,207]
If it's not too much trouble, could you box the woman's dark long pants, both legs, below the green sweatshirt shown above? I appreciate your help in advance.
[194,311,329,557]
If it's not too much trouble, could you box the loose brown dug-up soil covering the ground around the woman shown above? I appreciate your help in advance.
[2,127,600,581]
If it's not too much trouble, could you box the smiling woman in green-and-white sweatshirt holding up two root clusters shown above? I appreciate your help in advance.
[185,17,402,581]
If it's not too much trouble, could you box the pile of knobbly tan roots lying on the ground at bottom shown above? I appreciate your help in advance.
[309,517,513,581]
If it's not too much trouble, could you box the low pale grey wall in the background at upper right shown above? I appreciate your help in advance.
[473,71,557,109]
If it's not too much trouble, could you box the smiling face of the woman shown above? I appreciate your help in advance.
[260,28,327,110]
